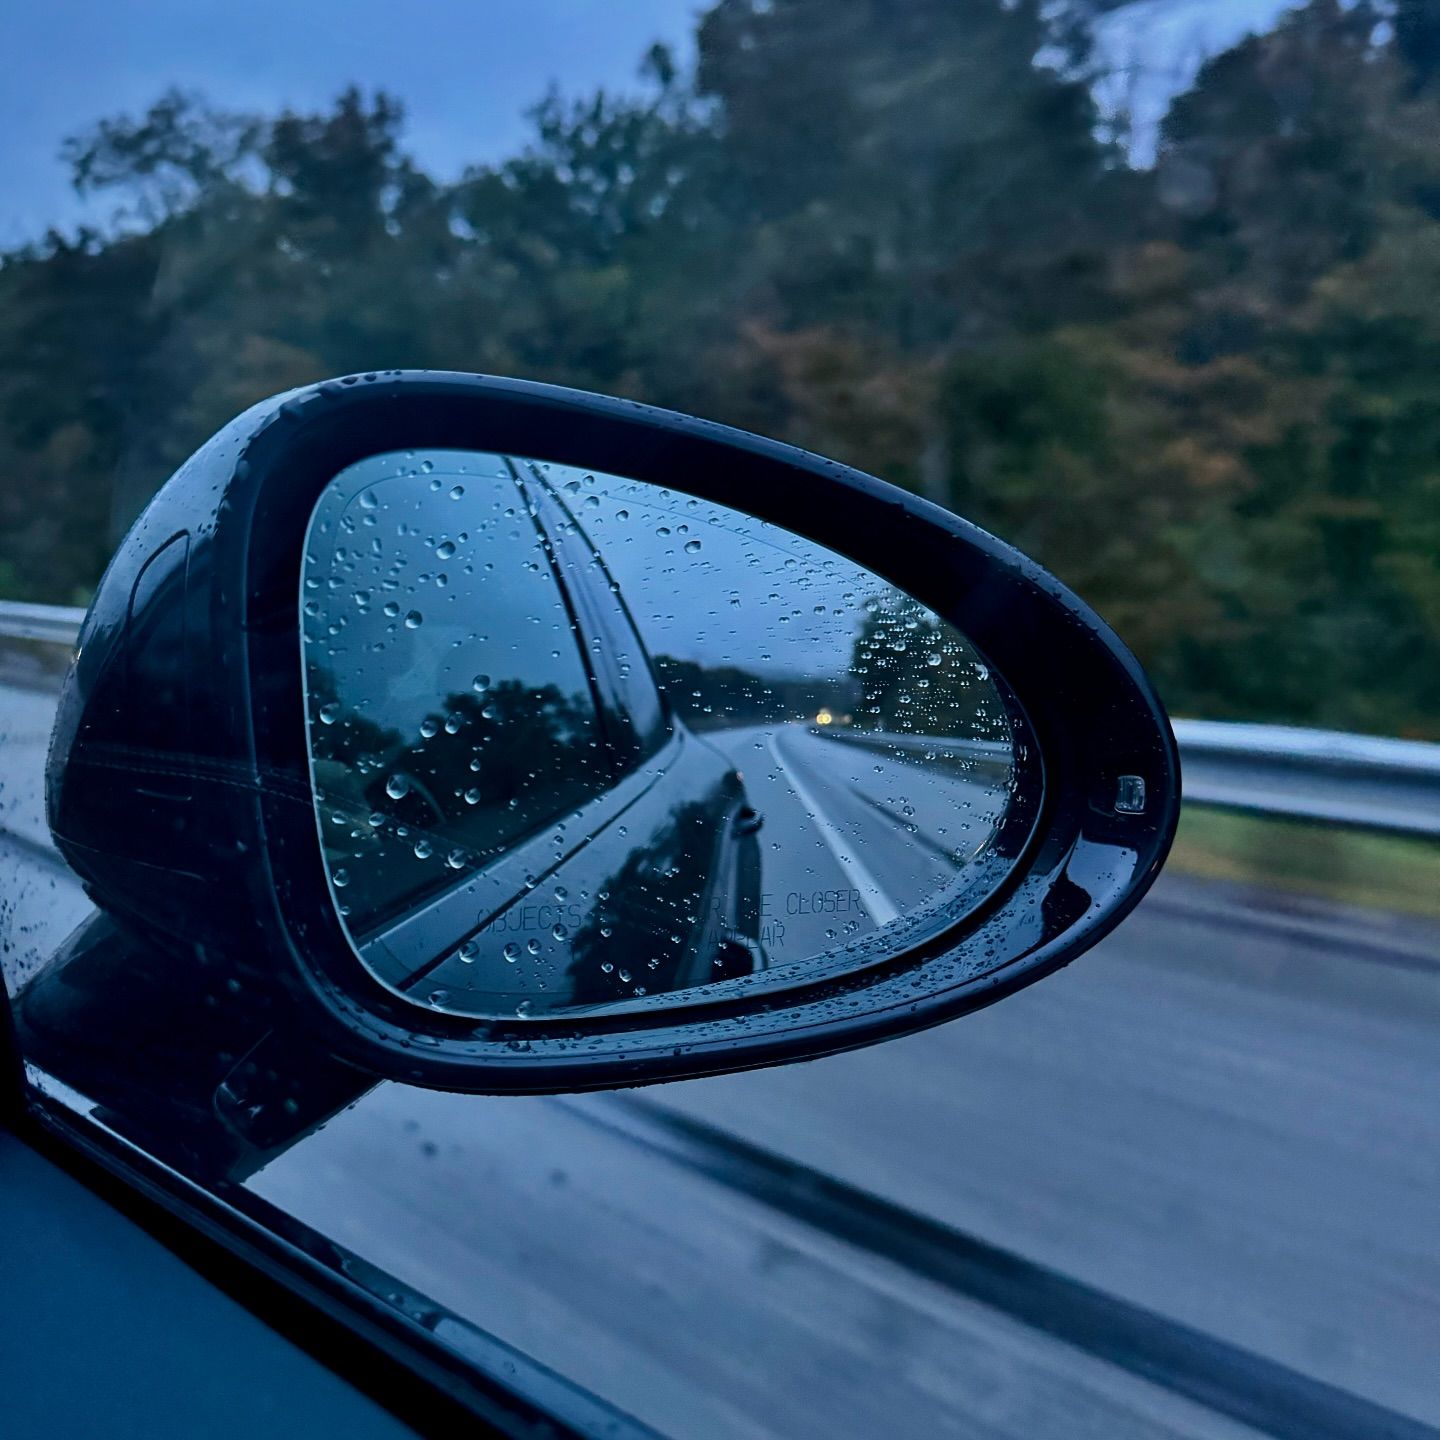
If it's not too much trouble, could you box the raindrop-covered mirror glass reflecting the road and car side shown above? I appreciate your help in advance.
[300,451,1040,1021]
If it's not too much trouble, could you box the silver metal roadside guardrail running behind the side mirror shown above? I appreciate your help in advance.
[0,600,1440,838]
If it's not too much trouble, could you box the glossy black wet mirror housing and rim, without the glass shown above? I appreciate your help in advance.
[50,372,1179,1093]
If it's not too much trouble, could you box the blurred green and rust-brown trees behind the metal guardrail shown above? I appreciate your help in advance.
[0,0,1440,736]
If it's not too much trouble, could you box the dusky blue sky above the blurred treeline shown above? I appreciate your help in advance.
[0,0,1284,245]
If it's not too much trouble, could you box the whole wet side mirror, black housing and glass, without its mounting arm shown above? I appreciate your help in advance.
[39,372,1179,1093]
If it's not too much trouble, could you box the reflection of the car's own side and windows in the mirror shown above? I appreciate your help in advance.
[311,455,763,1015]
